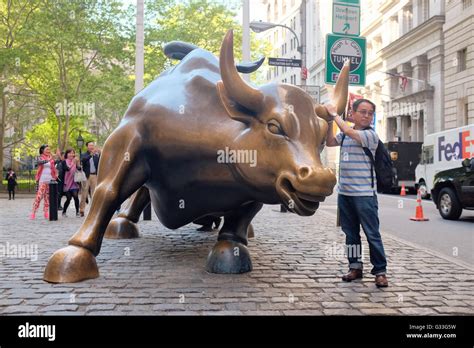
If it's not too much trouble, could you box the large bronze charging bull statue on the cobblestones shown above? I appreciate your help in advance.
[44,31,349,283]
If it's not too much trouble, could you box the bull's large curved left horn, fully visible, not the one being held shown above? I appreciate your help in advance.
[219,30,263,112]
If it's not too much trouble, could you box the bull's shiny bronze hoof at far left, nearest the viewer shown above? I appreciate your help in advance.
[43,245,99,283]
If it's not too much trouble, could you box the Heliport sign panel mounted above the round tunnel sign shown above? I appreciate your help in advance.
[332,2,360,36]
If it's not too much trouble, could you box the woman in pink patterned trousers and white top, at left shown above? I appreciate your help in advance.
[30,144,58,220]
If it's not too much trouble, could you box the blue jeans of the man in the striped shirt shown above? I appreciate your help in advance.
[337,194,387,275]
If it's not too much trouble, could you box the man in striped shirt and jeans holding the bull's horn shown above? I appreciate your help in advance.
[325,99,388,287]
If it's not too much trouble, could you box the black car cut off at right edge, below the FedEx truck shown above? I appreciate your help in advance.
[431,157,474,220]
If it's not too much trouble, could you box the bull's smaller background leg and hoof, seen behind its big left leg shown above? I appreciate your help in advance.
[105,186,150,239]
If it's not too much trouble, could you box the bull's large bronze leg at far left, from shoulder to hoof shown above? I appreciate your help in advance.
[43,126,148,283]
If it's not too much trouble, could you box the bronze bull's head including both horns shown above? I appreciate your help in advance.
[217,30,349,215]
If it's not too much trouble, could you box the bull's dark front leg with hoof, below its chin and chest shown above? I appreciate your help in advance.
[206,202,263,274]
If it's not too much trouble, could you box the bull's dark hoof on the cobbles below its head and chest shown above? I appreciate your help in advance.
[206,240,252,274]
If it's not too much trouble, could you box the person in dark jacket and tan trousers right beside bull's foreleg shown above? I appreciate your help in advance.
[79,141,100,216]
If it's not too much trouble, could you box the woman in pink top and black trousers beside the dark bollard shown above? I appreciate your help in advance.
[62,149,81,217]
